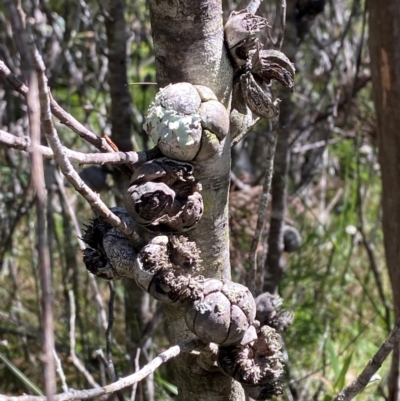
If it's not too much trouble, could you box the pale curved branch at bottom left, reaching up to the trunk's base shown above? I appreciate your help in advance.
[0,340,199,401]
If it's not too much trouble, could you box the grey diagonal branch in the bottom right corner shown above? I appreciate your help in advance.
[332,319,400,401]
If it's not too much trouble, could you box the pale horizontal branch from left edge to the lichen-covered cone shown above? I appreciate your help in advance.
[0,130,161,165]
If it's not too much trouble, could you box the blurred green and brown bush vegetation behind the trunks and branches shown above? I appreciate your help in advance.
[0,0,393,401]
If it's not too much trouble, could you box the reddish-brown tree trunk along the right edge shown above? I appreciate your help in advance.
[368,0,400,401]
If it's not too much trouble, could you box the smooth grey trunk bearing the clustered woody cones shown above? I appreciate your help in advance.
[149,0,244,401]
